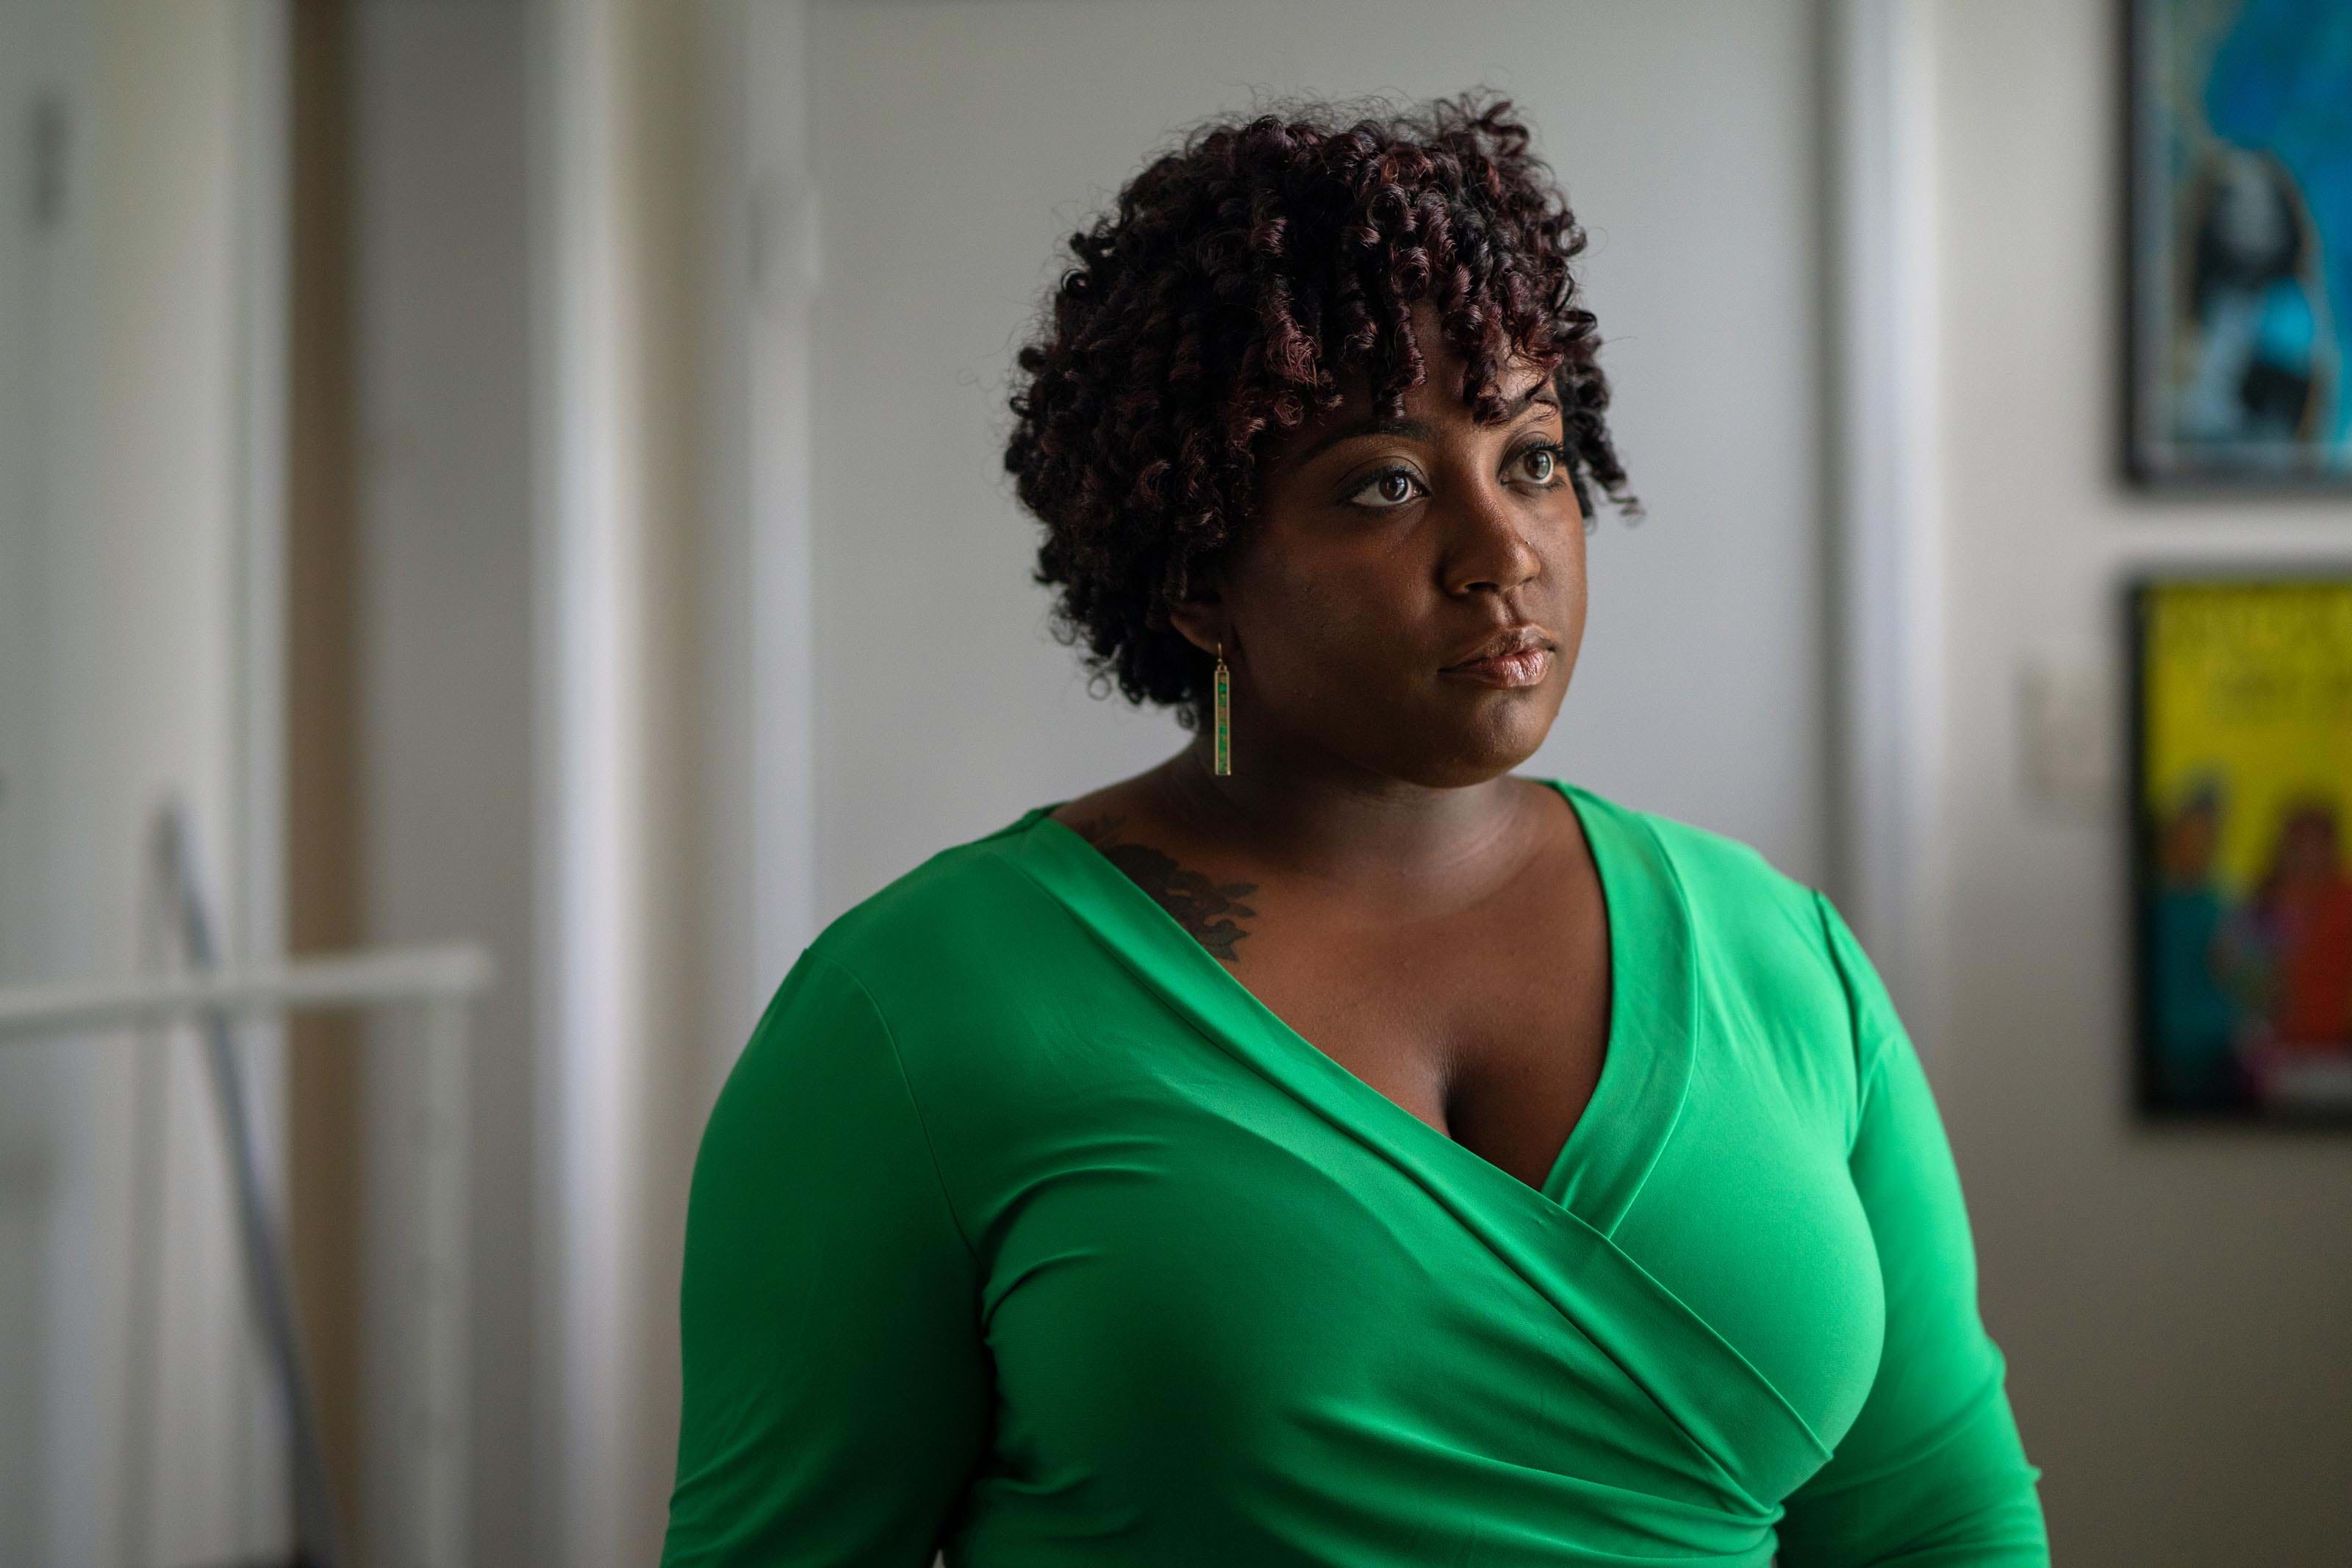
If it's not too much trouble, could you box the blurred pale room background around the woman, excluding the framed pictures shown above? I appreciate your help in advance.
[0,0,2352,1568]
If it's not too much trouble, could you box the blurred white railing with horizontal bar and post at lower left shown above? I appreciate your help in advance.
[0,945,494,1568]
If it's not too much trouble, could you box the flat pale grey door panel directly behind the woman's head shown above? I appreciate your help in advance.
[809,0,1827,917]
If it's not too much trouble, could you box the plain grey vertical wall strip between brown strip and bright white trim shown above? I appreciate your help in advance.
[351,0,538,1564]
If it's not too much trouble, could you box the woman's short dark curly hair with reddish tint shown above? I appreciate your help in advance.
[1004,92,1642,729]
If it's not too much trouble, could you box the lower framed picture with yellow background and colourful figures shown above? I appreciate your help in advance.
[2126,567,2352,1123]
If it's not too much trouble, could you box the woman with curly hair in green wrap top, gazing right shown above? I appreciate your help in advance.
[666,101,2046,1568]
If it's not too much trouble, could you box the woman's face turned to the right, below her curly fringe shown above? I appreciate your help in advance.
[1178,303,1585,788]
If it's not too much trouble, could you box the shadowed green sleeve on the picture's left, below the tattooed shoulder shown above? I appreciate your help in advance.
[661,950,990,1568]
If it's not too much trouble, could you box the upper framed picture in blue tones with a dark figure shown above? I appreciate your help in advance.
[2124,0,2352,489]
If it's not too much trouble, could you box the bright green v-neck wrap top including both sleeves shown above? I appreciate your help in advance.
[663,780,2048,1568]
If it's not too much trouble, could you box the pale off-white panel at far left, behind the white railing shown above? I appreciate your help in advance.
[0,0,284,1566]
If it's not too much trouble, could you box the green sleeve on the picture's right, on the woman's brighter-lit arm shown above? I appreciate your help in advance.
[1780,893,2048,1568]
